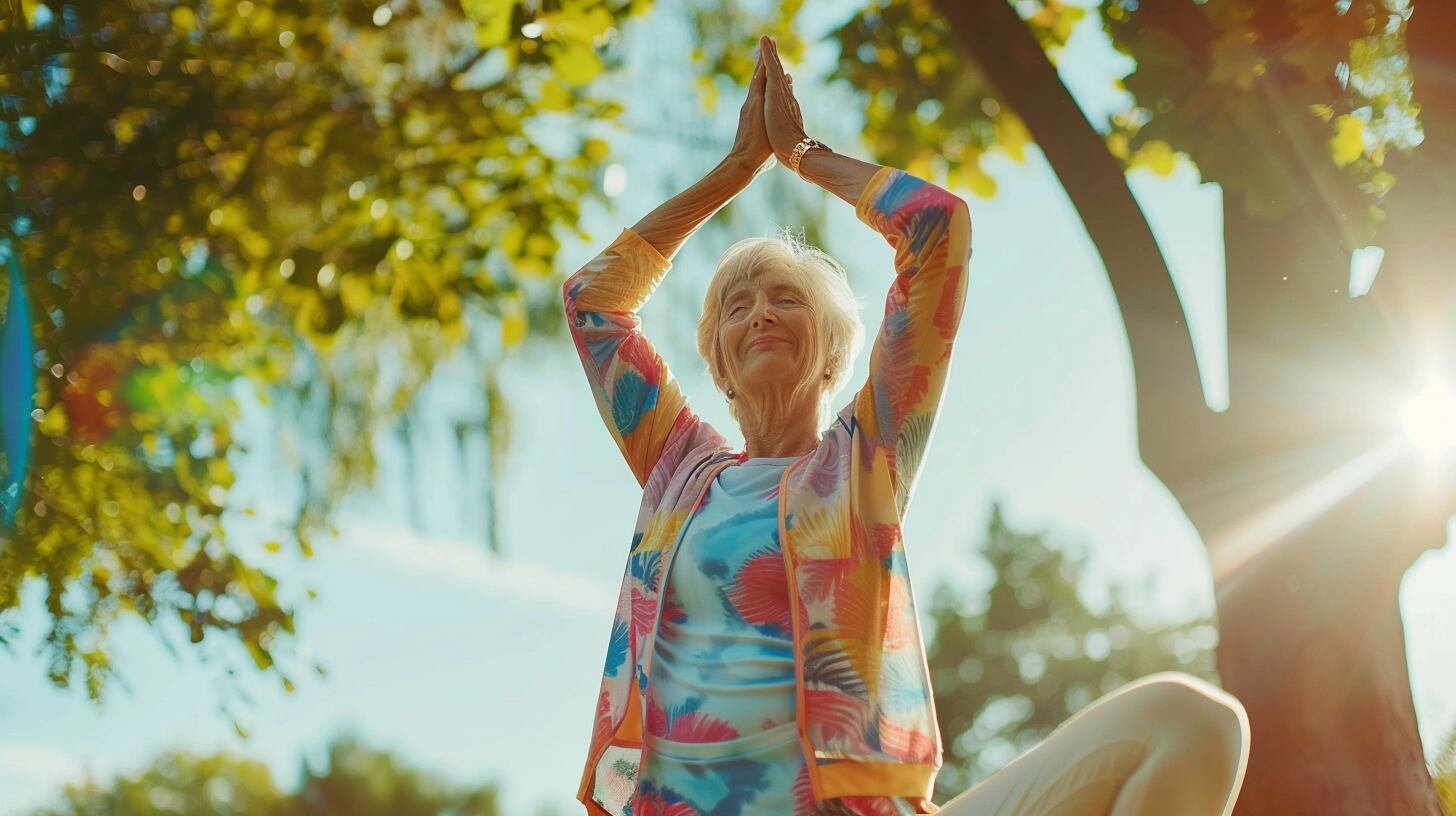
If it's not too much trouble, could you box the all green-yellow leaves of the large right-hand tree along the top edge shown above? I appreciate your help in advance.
[687,0,1421,230]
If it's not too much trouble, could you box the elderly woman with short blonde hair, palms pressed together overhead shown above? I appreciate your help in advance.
[562,38,1249,816]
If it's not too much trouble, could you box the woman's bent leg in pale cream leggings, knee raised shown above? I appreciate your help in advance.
[939,672,1249,816]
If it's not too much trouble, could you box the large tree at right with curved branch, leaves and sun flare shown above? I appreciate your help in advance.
[684,0,1456,815]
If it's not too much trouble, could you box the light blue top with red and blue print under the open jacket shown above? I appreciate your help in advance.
[628,456,914,816]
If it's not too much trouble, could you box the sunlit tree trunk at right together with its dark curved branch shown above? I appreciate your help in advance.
[939,0,1450,816]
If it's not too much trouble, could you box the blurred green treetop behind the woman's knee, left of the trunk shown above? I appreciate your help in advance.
[926,506,1217,799]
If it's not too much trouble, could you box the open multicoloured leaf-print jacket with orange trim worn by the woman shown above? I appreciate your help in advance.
[562,168,971,816]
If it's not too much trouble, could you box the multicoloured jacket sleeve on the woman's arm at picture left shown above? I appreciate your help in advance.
[562,229,697,487]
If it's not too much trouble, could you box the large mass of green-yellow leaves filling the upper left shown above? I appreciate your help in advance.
[0,0,646,699]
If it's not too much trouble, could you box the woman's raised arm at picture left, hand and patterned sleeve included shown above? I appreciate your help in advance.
[561,47,773,487]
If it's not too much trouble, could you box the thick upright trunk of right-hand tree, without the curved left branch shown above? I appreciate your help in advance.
[1205,1,1456,816]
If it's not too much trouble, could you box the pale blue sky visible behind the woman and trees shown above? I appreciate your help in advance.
[0,0,1456,816]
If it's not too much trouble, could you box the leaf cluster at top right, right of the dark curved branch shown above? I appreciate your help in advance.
[1105,0,1421,230]
